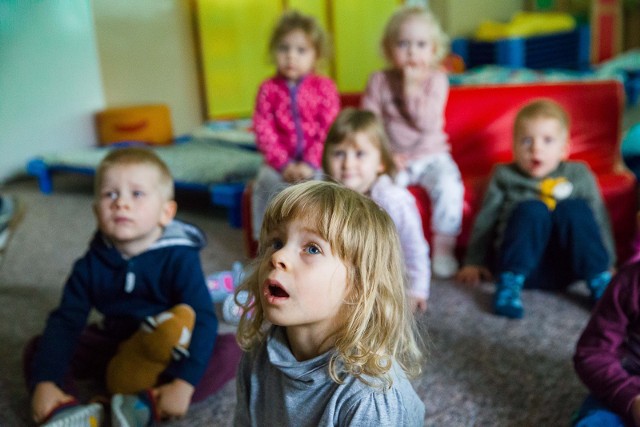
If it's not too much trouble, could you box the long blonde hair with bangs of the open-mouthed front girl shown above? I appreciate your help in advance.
[236,181,422,387]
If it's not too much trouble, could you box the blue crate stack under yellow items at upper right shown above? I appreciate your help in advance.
[451,25,591,70]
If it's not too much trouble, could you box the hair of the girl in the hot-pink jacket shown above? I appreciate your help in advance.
[269,10,331,68]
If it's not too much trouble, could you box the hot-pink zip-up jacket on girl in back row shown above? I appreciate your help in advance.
[253,74,340,171]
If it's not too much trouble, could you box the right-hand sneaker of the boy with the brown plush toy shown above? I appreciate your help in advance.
[111,391,155,427]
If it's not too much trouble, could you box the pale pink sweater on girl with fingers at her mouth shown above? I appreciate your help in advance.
[362,70,450,160]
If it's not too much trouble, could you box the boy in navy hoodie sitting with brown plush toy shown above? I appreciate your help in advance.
[25,148,240,425]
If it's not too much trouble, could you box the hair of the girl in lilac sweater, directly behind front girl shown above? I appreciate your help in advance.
[322,107,396,176]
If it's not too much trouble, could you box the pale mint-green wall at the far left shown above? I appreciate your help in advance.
[0,0,104,181]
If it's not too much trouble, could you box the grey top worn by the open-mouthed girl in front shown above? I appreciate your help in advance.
[234,327,424,427]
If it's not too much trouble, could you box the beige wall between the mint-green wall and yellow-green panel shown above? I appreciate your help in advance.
[93,0,203,136]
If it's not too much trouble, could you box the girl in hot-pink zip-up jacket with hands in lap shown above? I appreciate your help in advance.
[252,11,340,240]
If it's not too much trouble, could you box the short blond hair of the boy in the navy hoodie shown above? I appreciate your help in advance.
[94,147,174,200]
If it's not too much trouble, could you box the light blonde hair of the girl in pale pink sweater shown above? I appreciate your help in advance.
[381,6,449,65]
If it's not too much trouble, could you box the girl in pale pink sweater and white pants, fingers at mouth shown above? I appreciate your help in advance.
[362,7,464,277]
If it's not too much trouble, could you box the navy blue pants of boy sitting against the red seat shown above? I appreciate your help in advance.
[497,199,609,289]
